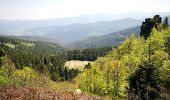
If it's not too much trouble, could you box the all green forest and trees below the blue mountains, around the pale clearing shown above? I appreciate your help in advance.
[0,15,170,100]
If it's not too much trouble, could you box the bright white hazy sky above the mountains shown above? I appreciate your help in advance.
[0,0,170,20]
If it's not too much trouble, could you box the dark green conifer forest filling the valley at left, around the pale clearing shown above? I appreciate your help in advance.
[0,37,112,81]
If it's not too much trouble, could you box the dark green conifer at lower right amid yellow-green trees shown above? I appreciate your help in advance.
[129,63,161,100]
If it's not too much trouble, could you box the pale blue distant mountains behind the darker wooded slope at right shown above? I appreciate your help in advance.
[0,12,170,43]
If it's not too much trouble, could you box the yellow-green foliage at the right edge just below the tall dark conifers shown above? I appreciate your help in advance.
[146,29,170,68]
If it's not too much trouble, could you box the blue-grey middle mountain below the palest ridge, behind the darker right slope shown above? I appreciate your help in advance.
[25,18,142,43]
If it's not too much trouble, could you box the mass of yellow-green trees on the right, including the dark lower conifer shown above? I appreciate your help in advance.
[76,19,170,100]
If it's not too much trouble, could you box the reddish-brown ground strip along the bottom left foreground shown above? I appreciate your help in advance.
[0,87,101,100]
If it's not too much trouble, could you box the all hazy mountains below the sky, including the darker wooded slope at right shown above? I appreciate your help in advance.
[0,12,170,48]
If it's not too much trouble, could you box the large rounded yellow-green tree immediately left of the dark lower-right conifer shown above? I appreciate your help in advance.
[76,57,127,96]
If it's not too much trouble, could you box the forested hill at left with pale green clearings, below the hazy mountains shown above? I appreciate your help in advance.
[0,36,64,52]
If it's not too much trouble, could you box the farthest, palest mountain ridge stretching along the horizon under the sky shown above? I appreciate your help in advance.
[0,12,170,35]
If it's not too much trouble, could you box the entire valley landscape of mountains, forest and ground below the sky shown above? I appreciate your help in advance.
[0,6,170,100]
